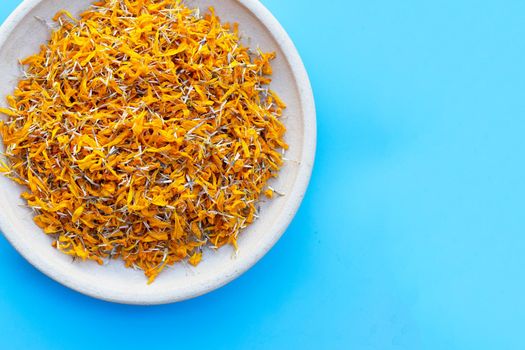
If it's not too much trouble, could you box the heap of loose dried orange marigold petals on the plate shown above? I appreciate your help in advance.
[0,0,287,282]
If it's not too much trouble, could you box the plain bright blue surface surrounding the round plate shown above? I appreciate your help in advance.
[0,0,525,350]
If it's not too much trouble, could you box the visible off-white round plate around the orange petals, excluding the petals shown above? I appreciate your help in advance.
[0,0,316,304]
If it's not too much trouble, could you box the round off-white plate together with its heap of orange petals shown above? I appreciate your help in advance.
[0,0,316,305]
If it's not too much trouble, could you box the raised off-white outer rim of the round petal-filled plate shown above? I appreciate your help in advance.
[0,0,317,305]
